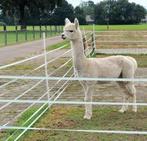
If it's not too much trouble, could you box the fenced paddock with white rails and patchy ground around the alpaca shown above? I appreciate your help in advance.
[0,27,147,141]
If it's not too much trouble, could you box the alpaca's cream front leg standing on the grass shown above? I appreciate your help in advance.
[84,87,93,119]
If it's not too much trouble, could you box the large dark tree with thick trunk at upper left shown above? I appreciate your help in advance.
[0,0,62,25]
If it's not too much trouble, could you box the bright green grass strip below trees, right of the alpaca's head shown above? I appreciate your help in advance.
[81,24,147,31]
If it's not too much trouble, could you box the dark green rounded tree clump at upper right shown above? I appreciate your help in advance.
[95,0,146,24]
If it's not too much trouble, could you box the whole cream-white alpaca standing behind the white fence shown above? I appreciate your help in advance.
[62,19,137,119]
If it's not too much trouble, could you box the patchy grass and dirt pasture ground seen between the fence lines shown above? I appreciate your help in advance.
[0,26,147,141]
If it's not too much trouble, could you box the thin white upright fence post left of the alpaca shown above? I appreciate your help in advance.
[43,32,50,105]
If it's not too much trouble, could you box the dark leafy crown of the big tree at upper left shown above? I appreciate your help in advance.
[0,0,62,25]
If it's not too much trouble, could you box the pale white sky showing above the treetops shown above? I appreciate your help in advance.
[67,0,147,8]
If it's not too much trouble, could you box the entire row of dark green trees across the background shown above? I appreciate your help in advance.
[0,0,146,25]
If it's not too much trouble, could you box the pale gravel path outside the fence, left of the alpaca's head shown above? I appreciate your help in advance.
[0,36,62,65]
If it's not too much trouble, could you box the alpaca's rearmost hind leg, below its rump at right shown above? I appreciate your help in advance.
[126,83,137,112]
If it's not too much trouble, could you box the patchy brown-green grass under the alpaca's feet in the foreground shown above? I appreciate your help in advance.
[9,106,147,141]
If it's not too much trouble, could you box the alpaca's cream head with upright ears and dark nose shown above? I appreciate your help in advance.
[62,18,81,40]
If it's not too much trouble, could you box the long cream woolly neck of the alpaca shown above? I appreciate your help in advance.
[71,38,86,71]
